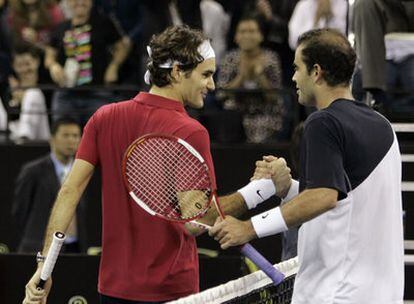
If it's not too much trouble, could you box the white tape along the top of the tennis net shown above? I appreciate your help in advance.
[168,257,298,304]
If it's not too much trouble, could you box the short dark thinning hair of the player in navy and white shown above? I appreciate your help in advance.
[298,29,356,86]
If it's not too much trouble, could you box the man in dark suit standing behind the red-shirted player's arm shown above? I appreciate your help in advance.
[12,118,86,253]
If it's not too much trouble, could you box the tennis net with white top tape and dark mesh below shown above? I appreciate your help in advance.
[169,257,298,304]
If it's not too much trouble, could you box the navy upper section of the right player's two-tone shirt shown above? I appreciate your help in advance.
[299,99,394,200]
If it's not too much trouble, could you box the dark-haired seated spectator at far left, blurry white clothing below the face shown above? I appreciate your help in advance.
[9,45,50,142]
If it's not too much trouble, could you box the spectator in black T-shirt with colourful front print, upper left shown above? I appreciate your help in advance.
[45,0,130,125]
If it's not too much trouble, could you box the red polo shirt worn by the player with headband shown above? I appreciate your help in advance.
[76,93,215,301]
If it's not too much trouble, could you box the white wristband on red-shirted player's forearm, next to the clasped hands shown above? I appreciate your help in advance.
[237,178,276,209]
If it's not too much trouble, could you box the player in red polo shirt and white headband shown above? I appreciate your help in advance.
[23,26,290,304]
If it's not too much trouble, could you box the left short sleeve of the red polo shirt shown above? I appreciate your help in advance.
[76,110,100,166]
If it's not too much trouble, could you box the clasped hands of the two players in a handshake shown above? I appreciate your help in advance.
[251,155,292,198]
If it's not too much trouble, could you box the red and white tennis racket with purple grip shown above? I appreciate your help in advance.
[122,134,284,285]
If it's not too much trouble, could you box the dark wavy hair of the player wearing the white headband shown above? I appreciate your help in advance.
[147,25,207,87]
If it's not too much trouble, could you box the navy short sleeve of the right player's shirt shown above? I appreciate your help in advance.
[300,113,347,200]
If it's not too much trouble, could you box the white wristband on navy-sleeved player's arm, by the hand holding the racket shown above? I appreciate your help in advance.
[250,207,288,238]
